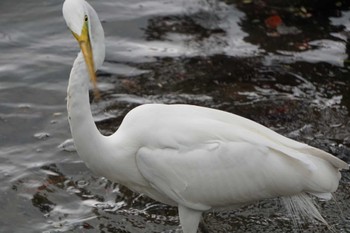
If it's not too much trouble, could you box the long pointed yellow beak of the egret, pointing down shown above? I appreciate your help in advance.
[72,23,100,99]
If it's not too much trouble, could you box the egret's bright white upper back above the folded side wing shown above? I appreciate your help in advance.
[125,104,349,169]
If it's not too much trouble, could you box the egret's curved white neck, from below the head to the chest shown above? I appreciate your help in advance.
[67,53,144,185]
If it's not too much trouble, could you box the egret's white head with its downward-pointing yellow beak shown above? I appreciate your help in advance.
[62,0,104,97]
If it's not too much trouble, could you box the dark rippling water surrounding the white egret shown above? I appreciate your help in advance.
[0,0,350,233]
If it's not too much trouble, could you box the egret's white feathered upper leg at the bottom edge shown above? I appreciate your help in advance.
[178,205,202,233]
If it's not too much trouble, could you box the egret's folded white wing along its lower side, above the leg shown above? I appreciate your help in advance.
[136,141,305,211]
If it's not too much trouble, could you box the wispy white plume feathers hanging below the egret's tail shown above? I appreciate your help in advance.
[281,193,332,231]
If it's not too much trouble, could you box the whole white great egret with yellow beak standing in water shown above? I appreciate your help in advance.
[63,0,349,233]
